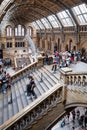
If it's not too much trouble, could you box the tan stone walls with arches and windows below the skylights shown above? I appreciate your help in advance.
[0,26,87,61]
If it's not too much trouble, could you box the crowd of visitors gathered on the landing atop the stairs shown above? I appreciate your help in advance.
[45,51,86,71]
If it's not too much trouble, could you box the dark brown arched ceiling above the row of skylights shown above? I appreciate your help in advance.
[0,0,87,24]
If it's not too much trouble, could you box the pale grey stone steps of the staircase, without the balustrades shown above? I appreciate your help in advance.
[0,61,64,130]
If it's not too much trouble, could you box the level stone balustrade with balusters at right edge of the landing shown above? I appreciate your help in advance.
[60,69,87,86]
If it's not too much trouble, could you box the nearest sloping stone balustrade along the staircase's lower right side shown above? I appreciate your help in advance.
[0,85,63,130]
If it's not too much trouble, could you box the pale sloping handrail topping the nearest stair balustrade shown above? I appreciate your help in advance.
[0,84,63,130]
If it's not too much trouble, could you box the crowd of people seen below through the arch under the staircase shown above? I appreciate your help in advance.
[60,108,87,130]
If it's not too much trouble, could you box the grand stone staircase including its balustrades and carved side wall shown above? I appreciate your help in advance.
[0,59,87,130]
